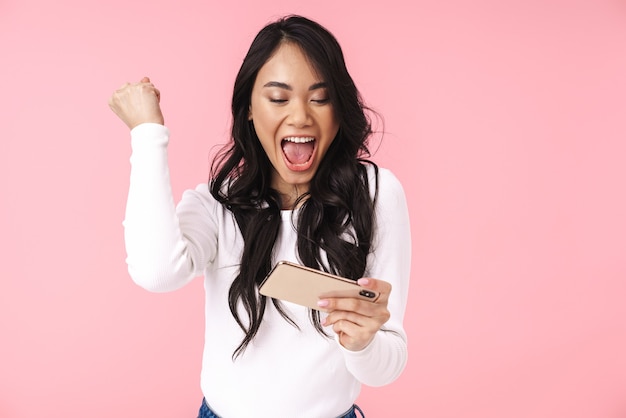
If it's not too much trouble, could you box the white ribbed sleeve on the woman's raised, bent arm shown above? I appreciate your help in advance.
[123,123,215,292]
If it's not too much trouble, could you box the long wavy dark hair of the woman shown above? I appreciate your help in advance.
[210,15,377,358]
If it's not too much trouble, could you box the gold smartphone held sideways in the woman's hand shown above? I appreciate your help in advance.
[259,261,379,310]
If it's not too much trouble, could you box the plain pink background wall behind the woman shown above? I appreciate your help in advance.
[0,0,626,418]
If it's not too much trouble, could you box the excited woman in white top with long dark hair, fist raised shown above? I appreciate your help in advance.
[110,16,411,418]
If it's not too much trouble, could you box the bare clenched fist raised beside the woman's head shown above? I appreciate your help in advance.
[109,77,164,129]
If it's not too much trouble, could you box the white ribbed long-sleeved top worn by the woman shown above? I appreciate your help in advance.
[123,123,411,418]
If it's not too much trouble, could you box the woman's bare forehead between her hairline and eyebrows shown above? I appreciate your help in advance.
[255,42,324,88]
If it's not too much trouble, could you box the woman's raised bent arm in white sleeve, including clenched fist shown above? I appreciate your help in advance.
[109,77,213,292]
